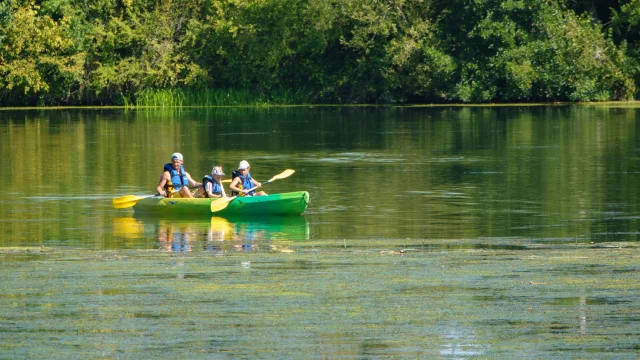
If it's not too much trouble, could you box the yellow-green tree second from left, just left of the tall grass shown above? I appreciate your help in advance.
[82,0,207,102]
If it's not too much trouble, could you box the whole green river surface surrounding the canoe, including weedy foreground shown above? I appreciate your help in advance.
[0,105,640,359]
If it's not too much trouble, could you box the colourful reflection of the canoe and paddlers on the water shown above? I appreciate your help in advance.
[113,216,309,253]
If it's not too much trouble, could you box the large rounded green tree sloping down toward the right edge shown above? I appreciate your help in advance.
[440,0,635,102]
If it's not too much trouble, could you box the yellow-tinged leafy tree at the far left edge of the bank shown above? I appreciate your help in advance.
[0,1,85,105]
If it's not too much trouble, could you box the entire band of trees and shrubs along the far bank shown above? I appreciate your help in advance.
[0,0,640,108]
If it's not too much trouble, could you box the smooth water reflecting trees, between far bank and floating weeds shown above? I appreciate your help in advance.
[0,105,640,248]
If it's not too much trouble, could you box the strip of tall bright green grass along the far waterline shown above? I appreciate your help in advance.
[129,89,312,107]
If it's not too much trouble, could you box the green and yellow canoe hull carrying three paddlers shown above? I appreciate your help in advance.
[133,191,309,216]
